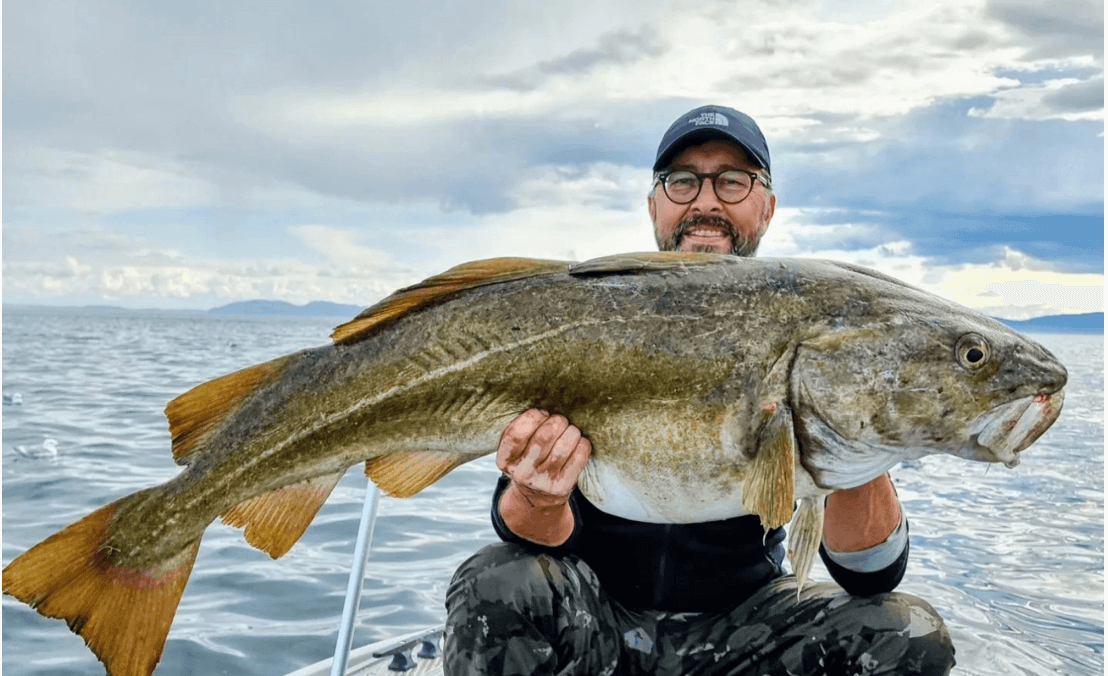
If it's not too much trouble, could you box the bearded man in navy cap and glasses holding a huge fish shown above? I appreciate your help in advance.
[445,106,954,676]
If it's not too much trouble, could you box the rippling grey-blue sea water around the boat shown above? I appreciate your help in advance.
[2,308,1104,676]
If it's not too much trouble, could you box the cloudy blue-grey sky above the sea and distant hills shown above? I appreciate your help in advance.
[2,0,1105,319]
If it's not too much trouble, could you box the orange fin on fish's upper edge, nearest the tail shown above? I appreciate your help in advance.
[165,355,293,464]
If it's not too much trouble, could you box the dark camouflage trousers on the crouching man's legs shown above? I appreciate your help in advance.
[444,543,954,676]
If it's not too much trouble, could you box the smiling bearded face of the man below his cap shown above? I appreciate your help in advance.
[647,141,777,256]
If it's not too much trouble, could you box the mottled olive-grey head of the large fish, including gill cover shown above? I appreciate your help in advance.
[790,303,1067,489]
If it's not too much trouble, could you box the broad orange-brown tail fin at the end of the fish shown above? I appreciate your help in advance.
[3,493,201,676]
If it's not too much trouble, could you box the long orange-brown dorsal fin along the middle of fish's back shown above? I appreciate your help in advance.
[331,258,570,345]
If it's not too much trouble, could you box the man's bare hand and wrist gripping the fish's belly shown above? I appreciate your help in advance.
[496,409,593,546]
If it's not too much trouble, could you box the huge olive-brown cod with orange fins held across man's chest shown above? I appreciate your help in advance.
[3,254,1066,676]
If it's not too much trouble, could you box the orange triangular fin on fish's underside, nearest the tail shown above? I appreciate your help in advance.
[222,470,346,559]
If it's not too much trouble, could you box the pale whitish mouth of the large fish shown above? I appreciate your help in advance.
[975,390,1066,468]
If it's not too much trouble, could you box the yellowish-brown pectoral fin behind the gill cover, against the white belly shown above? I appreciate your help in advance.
[742,403,797,529]
